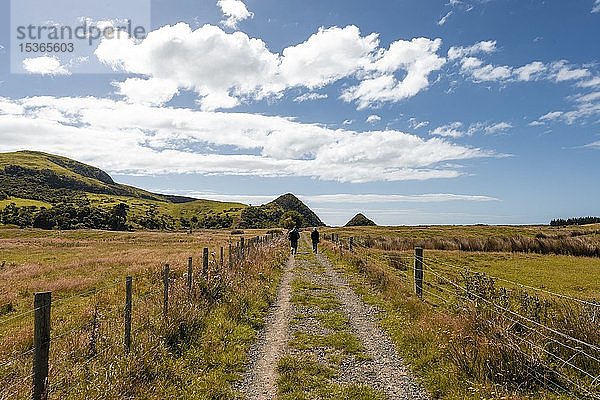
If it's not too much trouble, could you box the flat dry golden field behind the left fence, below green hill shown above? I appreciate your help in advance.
[0,229,264,318]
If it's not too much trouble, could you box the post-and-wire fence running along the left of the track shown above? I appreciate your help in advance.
[0,234,277,400]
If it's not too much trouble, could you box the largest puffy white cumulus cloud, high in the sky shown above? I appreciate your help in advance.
[95,23,445,111]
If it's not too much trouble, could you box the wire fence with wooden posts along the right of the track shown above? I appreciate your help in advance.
[326,234,600,399]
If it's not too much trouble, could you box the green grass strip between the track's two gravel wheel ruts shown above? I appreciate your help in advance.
[277,242,386,400]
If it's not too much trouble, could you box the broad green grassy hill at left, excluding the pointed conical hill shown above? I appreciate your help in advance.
[0,151,246,229]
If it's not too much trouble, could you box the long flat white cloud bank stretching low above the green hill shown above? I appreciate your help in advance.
[0,97,496,182]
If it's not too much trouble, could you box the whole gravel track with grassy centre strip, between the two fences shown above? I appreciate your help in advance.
[241,236,428,400]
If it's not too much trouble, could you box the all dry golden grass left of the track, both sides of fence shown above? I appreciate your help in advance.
[0,229,285,399]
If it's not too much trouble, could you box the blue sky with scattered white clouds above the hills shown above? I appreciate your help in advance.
[0,0,600,225]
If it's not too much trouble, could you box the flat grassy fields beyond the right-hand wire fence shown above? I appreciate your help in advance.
[324,224,600,299]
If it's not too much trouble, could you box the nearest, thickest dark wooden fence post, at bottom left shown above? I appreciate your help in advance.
[32,292,52,400]
